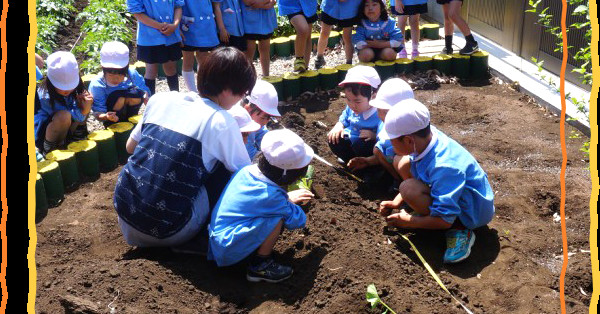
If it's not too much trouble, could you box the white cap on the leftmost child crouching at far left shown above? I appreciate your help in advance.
[46,51,80,91]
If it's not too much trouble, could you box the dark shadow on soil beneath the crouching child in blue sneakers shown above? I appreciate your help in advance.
[384,226,500,279]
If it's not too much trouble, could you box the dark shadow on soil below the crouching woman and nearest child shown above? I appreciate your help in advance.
[123,242,327,310]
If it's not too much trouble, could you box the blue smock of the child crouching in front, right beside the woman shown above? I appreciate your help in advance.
[208,165,306,266]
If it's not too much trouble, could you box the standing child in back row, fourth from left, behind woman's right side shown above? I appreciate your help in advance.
[242,0,277,76]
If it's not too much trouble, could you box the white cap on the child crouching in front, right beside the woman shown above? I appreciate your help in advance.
[260,129,315,173]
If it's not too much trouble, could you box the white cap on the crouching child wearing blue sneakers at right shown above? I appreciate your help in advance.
[384,99,430,139]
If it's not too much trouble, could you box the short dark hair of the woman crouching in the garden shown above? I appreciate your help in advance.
[198,47,256,97]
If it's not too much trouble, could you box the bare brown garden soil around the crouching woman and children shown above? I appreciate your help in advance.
[36,77,592,313]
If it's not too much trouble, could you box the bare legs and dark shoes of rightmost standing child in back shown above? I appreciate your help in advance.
[436,0,479,55]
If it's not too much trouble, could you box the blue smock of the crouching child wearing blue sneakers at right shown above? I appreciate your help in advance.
[410,127,495,229]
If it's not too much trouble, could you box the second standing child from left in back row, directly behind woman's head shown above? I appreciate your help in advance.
[181,0,219,93]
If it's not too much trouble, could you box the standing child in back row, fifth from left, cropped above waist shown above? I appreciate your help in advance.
[277,0,318,73]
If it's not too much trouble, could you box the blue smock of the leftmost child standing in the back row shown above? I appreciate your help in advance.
[127,0,185,46]
